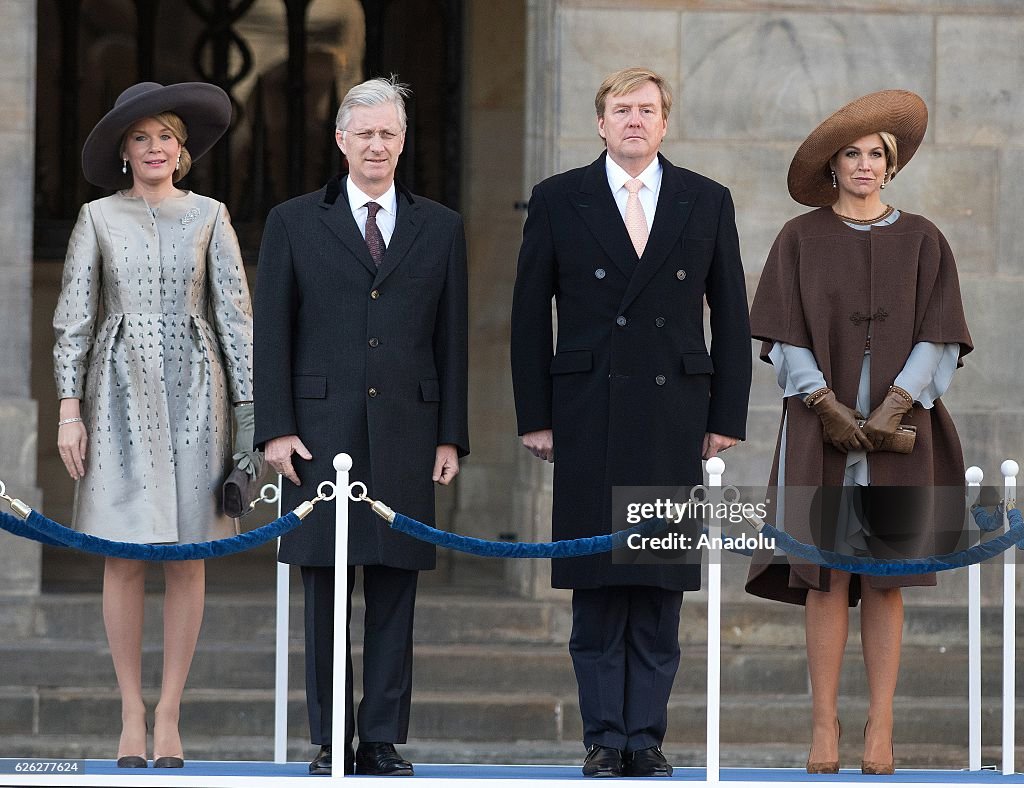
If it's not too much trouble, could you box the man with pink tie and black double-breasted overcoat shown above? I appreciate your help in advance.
[512,69,751,777]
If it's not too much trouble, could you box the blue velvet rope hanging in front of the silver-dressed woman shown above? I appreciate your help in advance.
[0,510,302,561]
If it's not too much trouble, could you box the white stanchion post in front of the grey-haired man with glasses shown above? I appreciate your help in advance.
[331,453,352,782]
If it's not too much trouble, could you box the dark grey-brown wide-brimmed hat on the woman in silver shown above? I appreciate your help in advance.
[82,82,231,189]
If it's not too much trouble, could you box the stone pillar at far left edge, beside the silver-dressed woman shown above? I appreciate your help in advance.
[0,0,41,595]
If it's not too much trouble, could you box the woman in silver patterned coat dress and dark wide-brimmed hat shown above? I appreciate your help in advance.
[53,82,252,768]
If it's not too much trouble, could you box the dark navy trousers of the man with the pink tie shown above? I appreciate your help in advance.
[569,585,683,752]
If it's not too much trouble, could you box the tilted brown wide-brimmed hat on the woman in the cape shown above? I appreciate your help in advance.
[786,90,928,208]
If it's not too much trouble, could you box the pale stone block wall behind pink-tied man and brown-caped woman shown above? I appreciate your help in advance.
[519,0,1024,597]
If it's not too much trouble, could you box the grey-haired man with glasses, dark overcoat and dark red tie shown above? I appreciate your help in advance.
[254,79,469,775]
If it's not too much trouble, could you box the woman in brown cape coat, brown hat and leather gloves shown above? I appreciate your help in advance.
[746,90,972,774]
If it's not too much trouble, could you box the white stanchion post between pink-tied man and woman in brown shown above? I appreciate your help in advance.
[705,456,725,785]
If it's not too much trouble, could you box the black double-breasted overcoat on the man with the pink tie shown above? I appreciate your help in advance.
[512,154,751,590]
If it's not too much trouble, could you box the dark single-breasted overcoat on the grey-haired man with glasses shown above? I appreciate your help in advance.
[253,173,469,569]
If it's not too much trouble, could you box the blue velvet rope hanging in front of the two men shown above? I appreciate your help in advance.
[391,515,666,558]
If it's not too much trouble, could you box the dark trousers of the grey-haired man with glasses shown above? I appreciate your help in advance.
[301,566,419,746]
